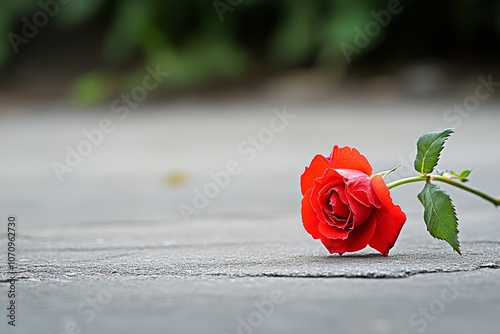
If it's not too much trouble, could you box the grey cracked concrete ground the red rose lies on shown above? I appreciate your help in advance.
[0,98,500,334]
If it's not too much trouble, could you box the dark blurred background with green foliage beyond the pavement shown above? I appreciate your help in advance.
[0,0,500,105]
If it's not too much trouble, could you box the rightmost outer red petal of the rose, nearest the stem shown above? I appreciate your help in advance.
[369,175,406,256]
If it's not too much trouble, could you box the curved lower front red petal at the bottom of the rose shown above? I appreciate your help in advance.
[321,215,375,255]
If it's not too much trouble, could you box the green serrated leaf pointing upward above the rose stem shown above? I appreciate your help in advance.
[415,129,453,174]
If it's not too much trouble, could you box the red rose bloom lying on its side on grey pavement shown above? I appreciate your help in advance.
[300,146,406,256]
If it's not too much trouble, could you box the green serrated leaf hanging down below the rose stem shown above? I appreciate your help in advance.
[418,183,462,255]
